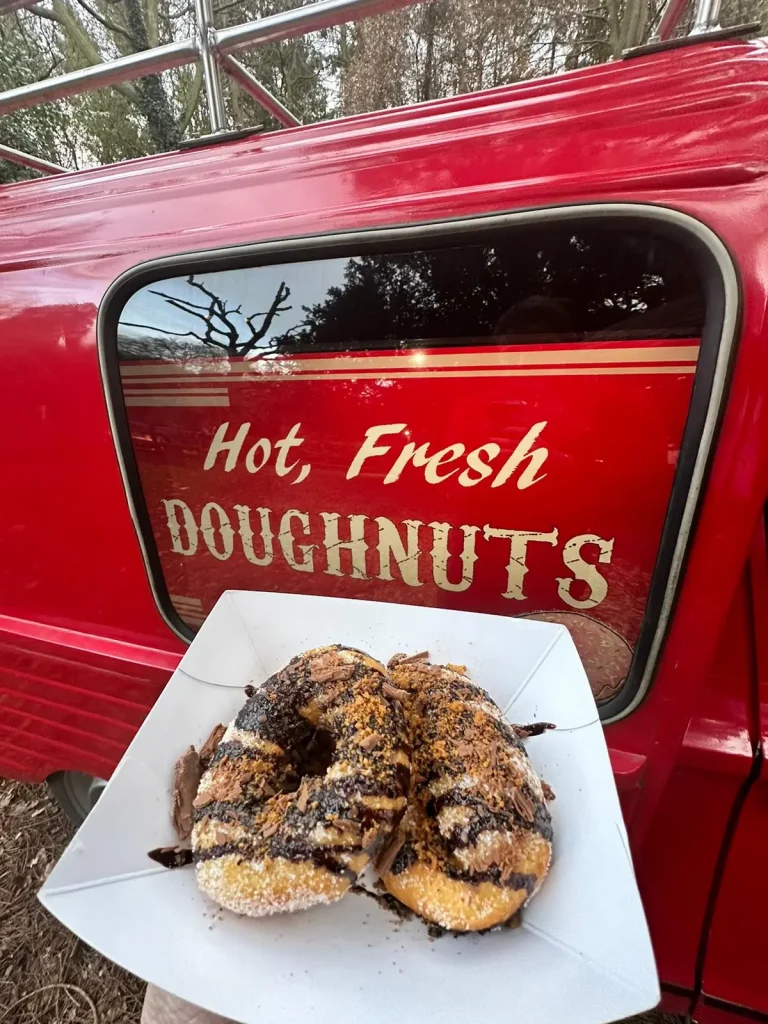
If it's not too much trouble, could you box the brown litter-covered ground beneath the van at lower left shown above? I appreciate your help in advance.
[0,779,679,1024]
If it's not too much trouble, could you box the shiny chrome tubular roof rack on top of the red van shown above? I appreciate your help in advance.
[0,0,741,174]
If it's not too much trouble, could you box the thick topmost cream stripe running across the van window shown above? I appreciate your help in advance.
[120,345,698,383]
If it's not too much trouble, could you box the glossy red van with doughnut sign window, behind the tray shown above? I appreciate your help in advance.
[0,3,768,1022]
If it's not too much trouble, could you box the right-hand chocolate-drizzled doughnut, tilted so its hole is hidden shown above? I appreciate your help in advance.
[380,655,552,932]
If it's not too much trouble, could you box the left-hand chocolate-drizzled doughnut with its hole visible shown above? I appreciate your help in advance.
[191,644,411,918]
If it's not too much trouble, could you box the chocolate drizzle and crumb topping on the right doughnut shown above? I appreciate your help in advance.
[384,659,552,927]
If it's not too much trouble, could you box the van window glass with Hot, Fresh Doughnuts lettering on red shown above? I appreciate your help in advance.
[113,222,706,700]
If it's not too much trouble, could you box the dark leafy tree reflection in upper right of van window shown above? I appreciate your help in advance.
[276,228,703,351]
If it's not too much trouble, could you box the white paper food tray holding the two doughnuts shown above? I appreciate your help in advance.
[40,591,659,1024]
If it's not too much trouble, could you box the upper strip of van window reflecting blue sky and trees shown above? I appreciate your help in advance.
[120,225,705,361]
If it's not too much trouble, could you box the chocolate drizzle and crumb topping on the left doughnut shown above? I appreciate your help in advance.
[194,645,411,874]
